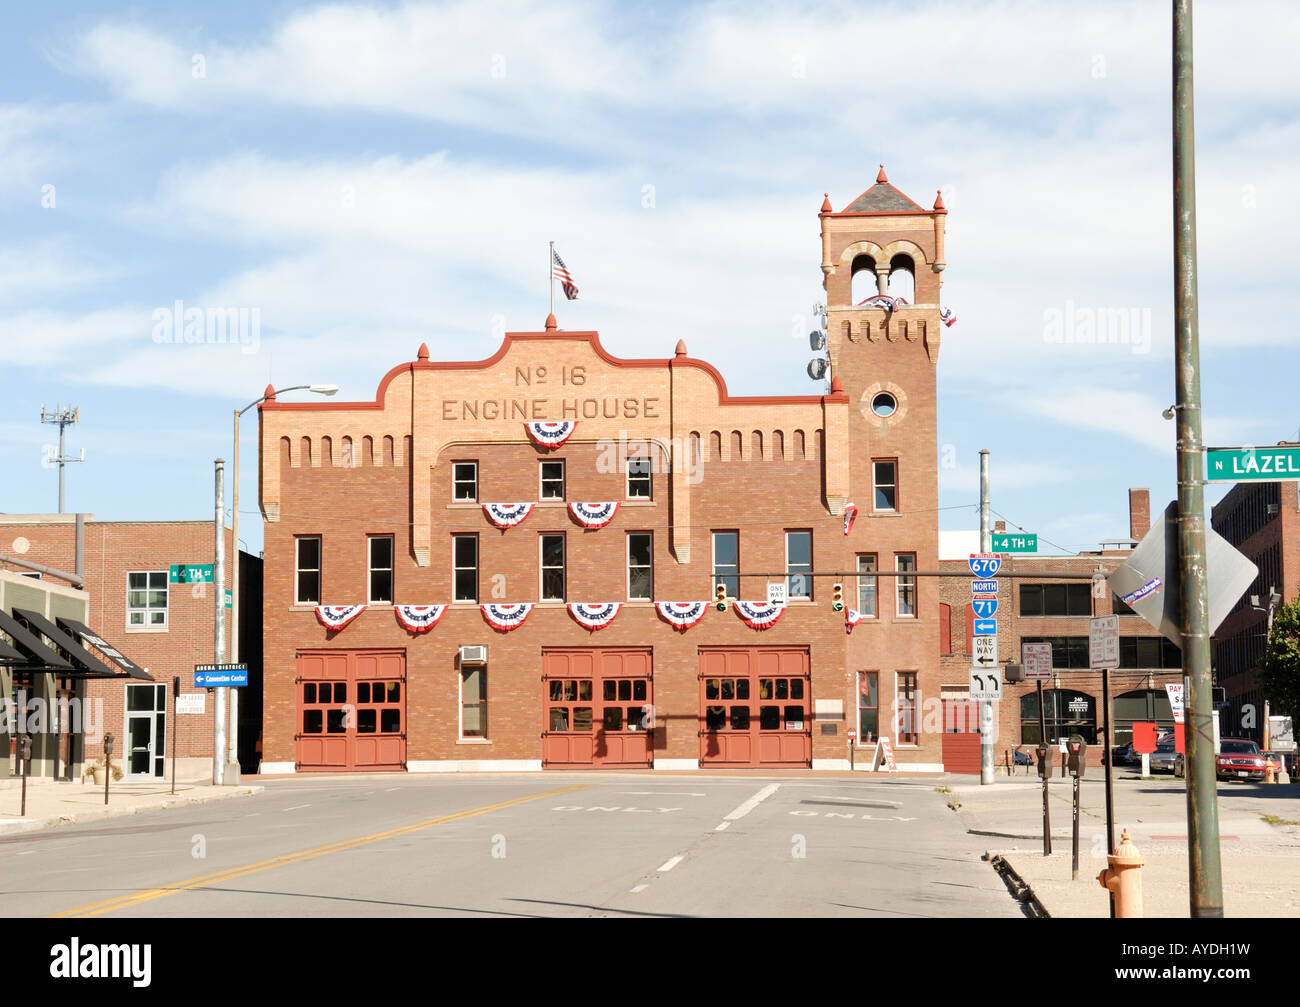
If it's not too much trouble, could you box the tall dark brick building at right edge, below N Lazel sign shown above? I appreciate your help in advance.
[1210,465,1300,741]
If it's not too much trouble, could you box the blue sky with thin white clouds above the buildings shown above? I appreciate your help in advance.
[0,0,1300,551]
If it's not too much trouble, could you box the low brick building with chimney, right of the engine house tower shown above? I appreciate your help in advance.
[940,489,1182,773]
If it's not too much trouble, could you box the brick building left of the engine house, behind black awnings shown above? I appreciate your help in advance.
[0,515,261,778]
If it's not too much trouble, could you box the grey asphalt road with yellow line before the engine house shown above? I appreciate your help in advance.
[0,773,1021,917]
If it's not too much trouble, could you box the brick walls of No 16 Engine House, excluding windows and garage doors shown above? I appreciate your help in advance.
[260,171,943,772]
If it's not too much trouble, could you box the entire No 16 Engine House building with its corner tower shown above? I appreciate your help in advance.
[260,170,945,772]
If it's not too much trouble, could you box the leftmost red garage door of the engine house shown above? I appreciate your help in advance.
[295,651,406,772]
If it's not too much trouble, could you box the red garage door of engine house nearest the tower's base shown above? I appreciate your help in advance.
[699,647,813,767]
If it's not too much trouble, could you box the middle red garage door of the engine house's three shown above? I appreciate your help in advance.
[542,650,654,769]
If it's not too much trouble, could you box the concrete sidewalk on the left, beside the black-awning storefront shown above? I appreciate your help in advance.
[0,778,265,835]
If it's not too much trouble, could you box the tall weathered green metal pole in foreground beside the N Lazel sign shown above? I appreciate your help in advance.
[1174,0,1223,917]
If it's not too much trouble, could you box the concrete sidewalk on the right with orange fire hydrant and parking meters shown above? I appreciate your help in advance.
[944,772,1300,919]
